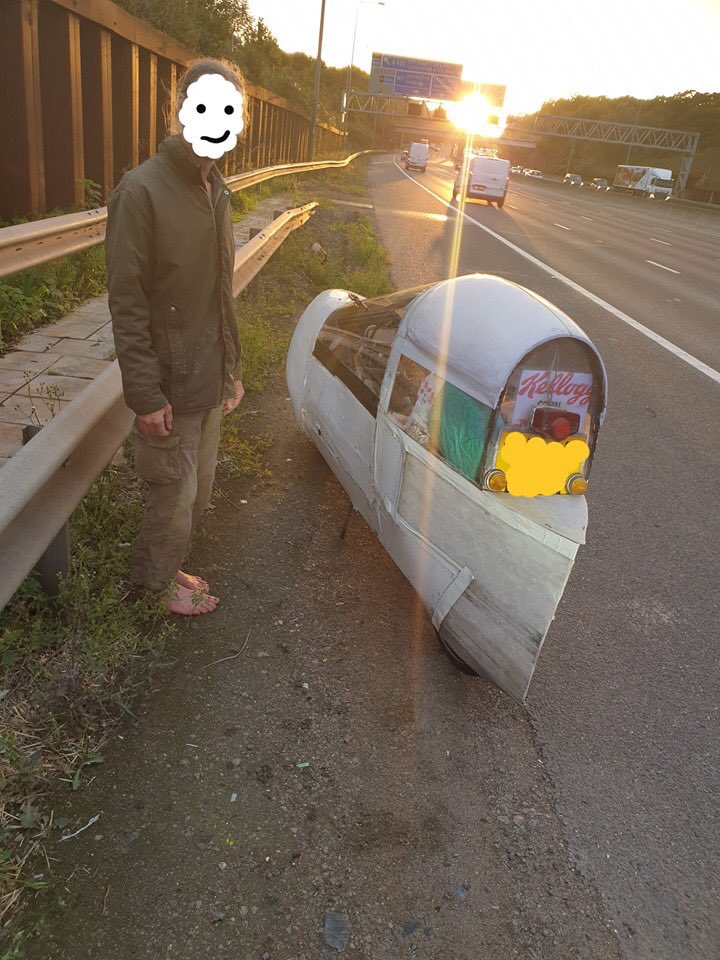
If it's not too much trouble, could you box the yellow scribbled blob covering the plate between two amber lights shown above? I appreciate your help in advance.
[496,432,590,497]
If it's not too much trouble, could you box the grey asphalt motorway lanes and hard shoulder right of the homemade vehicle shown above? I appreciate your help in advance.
[370,158,720,960]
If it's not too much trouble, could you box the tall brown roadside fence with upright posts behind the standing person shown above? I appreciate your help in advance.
[0,0,344,220]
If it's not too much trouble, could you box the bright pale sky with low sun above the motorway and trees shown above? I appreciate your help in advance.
[245,0,720,113]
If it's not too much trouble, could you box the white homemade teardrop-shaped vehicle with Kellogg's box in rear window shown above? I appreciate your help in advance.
[287,274,606,701]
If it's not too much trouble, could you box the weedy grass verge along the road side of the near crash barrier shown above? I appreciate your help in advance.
[0,154,391,948]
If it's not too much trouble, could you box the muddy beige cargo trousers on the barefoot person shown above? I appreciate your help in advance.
[131,404,222,590]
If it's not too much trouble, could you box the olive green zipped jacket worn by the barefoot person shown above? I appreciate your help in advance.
[105,136,242,414]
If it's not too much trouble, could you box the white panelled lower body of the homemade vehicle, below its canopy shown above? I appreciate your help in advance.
[287,282,587,701]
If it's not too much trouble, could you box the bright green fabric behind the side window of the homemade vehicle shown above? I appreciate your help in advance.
[429,383,492,481]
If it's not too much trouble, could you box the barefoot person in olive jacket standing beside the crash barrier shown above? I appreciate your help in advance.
[105,60,245,614]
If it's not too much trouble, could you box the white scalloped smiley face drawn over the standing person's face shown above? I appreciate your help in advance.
[178,73,245,160]
